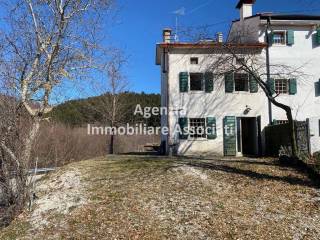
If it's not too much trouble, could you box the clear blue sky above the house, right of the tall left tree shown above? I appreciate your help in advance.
[108,0,320,93]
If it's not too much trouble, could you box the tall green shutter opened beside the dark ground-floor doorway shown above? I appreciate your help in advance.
[223,116,237,156]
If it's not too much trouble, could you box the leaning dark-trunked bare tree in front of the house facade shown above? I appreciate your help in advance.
[205,43,304,159]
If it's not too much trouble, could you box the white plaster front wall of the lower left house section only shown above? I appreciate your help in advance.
[168,51,268,155]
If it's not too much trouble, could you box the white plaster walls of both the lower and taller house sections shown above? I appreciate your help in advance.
[162,21,320,155]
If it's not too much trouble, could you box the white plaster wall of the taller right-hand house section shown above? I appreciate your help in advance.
[259,26,320,153]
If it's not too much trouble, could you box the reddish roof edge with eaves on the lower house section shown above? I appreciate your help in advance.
[156,42,267,65]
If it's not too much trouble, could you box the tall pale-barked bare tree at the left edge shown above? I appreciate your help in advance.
[0,0,112,224]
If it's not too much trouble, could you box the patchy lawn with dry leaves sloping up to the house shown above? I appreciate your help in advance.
[0,156,320,240]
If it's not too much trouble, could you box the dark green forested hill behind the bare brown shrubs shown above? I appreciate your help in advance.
[50,92,160,127]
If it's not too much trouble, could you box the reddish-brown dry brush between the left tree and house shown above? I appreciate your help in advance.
[31,122,160,167]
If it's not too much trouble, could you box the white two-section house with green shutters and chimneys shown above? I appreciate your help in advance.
[156,0,320,156]
